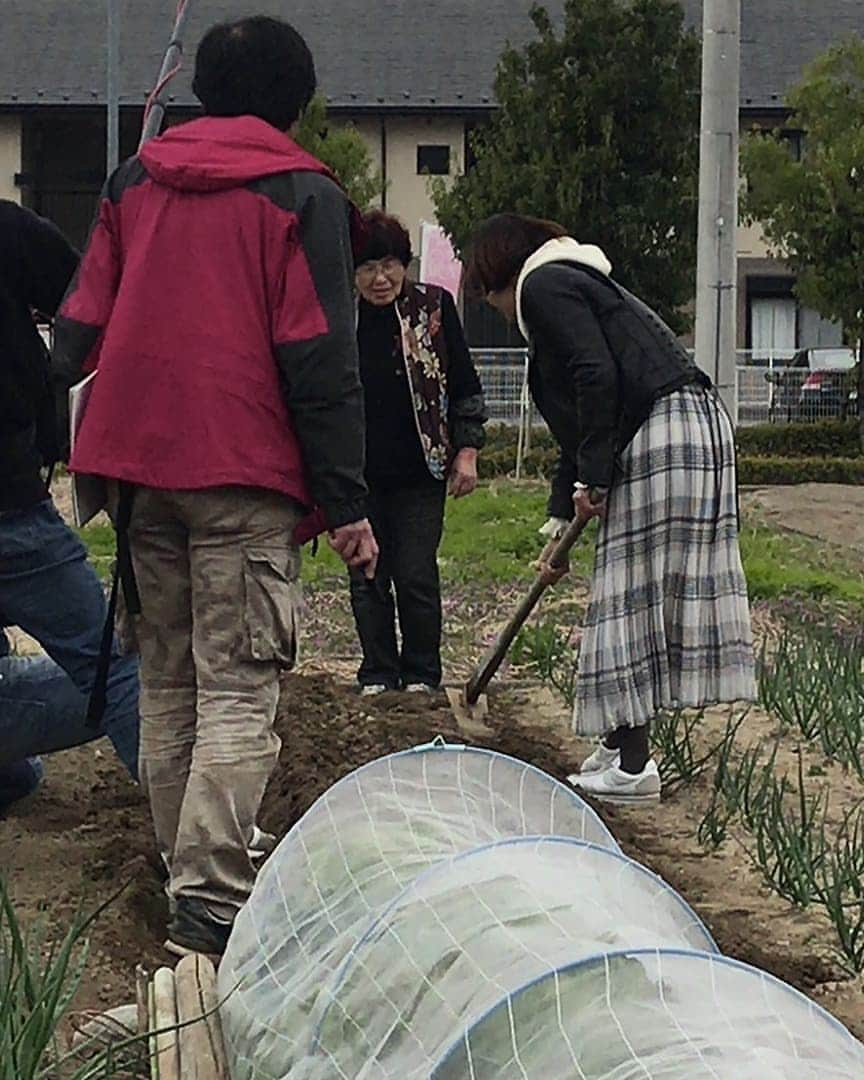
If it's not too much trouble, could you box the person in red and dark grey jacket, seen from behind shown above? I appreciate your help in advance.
[54,16,377,954]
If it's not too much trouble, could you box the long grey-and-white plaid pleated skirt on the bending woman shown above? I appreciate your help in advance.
[573,387,756,735]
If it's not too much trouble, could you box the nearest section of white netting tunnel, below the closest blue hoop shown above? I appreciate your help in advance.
[431,950,864,1080]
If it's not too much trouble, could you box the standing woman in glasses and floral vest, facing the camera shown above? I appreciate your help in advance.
[351,212,486,694]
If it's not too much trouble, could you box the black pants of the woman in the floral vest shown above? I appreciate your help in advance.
[351,476,447,689]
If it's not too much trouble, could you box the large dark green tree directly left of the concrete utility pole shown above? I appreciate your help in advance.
[432,0,700,329]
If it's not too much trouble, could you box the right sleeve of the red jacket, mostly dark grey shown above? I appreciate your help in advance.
[267,173,366,528]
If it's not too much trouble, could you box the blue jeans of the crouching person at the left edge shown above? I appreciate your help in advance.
[0,500,138,804]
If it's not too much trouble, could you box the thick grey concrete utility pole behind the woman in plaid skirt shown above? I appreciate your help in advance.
[696,0,741,422]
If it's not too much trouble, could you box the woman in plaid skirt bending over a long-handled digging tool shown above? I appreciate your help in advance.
[469,214,755,802]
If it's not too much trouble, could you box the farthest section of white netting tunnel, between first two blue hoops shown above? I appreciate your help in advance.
[219,745,618,1080]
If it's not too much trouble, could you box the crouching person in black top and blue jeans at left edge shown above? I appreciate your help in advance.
[0,199,138,813]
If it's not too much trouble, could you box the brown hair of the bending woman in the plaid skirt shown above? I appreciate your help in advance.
[465,214,567,296]
